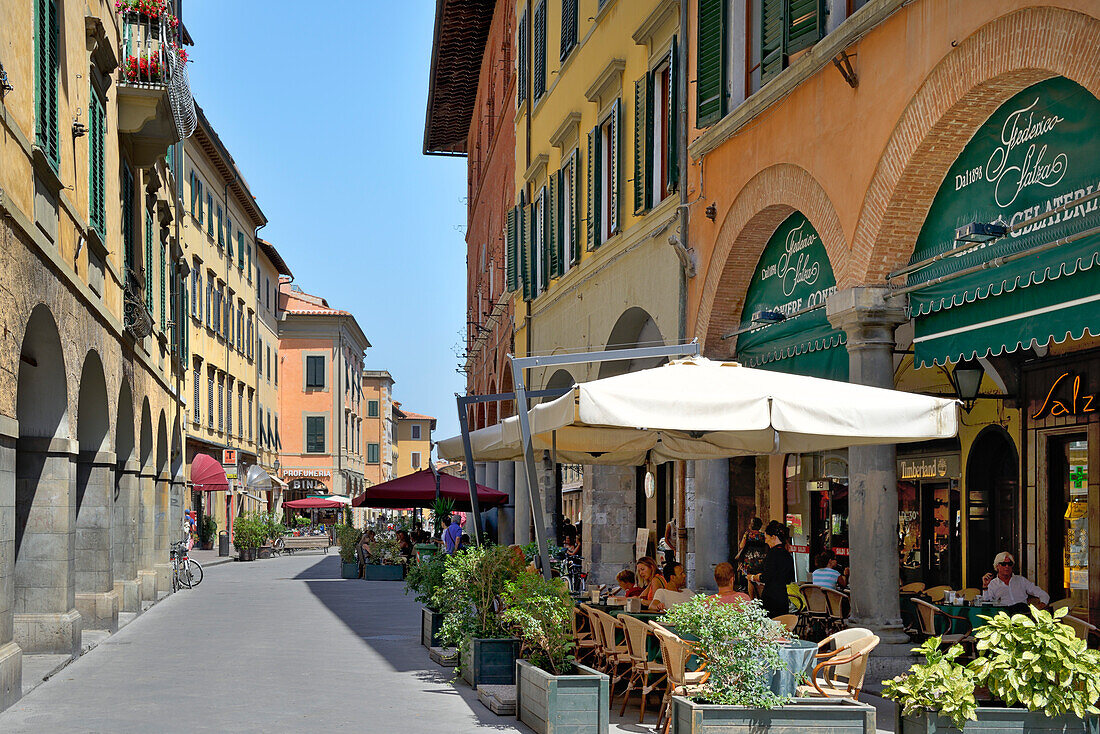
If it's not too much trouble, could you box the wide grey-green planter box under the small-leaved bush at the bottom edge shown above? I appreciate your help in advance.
[672,695,876,734]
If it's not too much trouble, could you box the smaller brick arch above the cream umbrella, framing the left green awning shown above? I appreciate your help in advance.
[695,163,848,358]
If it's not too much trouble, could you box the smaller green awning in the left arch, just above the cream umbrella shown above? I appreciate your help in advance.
[737,308,848,382]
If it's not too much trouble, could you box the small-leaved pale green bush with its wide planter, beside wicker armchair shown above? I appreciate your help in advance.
[662,594,876,734]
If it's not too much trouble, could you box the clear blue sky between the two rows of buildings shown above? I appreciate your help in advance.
[183,0,466,448]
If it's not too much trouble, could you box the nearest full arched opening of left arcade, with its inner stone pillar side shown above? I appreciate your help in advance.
[12,305,80,656]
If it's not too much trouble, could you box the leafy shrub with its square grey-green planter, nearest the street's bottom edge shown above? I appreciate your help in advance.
[501,572,611,734]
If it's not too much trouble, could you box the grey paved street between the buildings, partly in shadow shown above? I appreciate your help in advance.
[0,554,884,734]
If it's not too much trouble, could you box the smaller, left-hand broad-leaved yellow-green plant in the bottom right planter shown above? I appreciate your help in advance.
[882,637,978,731]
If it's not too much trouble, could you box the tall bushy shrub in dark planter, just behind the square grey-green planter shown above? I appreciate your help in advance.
[431,546,527,688]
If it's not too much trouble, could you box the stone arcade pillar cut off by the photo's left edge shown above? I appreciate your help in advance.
[0,416,23,711]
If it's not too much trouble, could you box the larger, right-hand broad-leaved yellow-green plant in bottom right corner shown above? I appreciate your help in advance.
[969,606,1100,719]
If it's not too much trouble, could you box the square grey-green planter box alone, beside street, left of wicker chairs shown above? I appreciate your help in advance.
[516,660,611,734]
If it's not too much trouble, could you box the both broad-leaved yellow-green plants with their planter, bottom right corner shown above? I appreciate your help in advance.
[882,606,1100,734]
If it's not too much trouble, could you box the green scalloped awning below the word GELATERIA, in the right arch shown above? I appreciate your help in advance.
[913,257,1100,368]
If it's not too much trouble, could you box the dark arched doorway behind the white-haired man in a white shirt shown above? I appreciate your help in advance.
[966,426,1021,589]
